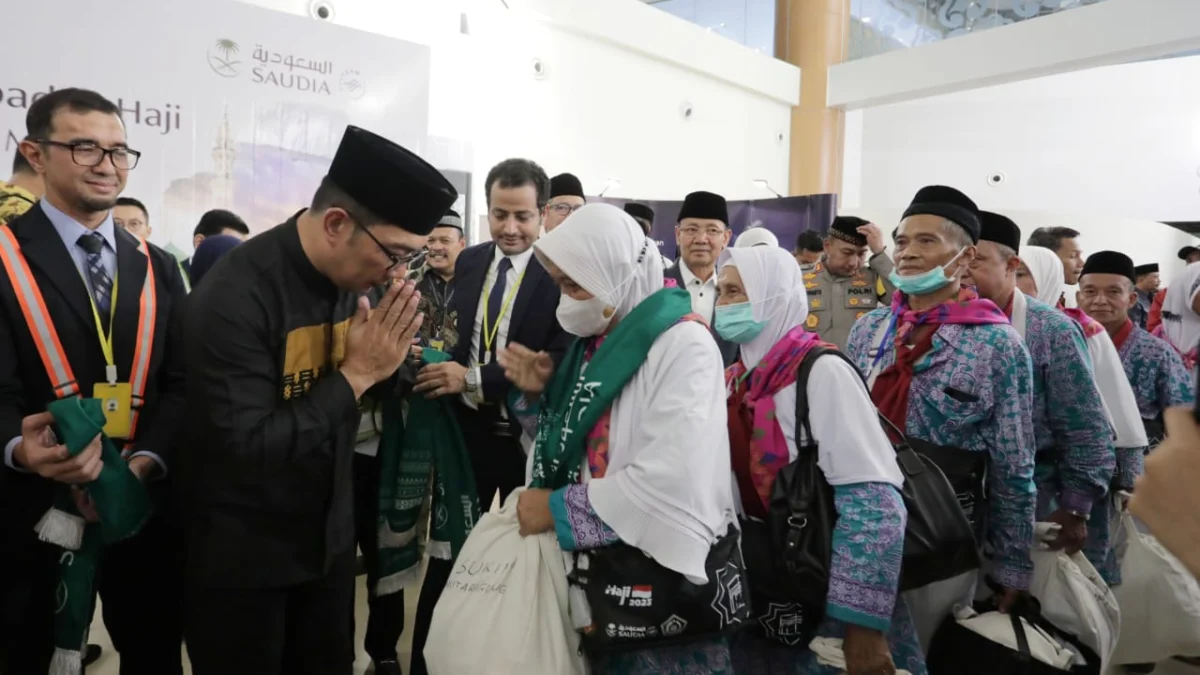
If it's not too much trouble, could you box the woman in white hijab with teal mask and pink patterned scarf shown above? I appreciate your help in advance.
[714,247,925,675]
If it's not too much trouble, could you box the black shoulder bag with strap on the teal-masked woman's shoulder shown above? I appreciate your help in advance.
[742,347,838,646]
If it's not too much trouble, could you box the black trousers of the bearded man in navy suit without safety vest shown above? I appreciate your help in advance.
[409,406,526,675]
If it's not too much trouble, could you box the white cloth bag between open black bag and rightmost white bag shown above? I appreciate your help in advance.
[1030,542,1121,673]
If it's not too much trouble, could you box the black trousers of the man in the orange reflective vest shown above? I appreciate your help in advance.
[98,513,184,675]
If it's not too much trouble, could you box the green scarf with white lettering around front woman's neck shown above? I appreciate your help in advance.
[530,288,691,490]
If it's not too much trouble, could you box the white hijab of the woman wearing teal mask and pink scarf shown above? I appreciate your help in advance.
[722,246,904,488]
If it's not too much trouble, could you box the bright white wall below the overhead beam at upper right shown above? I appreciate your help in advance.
[845,53,1200,278]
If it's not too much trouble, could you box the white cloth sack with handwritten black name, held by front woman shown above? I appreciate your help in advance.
[425,489,586,675]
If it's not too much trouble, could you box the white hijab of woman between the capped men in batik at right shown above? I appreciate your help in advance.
[1020,246,1147,448]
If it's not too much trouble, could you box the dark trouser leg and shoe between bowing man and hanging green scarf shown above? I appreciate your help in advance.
[352,454,404,662]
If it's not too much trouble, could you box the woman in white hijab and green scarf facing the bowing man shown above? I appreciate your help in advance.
[500,204,734,675]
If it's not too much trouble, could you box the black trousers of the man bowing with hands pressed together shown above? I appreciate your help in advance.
[184,549,355,675]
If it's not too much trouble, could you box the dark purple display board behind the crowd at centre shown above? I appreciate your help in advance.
[589,195,838,258]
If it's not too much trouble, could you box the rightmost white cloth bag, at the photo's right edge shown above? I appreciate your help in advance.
[1112,512,1200,664]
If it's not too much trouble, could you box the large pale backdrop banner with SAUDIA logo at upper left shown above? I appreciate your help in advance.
[0,0,430,260]
